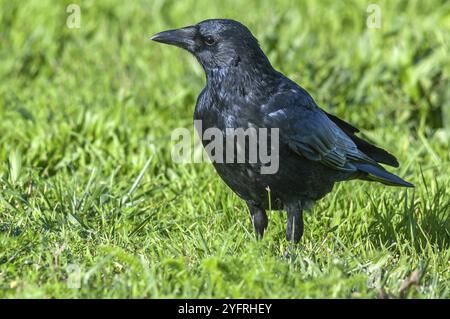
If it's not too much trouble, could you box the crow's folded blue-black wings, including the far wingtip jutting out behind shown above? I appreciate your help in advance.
[269,97,413,187]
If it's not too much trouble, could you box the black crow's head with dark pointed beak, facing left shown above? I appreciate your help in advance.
[151,19,270,72]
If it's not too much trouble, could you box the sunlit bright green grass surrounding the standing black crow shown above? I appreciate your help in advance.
[0,0,450,298]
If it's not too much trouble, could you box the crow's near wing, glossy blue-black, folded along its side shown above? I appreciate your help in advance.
[265,91,413,187]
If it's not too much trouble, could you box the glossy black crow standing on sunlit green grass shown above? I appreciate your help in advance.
[151,19,413,242]
